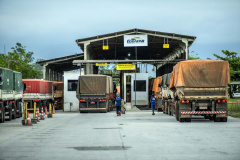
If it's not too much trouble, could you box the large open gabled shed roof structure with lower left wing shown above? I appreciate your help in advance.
[38,28,196,110]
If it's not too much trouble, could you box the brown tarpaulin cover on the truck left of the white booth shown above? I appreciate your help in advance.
[79,75,109,94]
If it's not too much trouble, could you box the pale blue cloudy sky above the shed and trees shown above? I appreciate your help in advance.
[0,0,240,59]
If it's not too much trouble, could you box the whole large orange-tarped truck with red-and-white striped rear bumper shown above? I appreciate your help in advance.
[170,60,230,122]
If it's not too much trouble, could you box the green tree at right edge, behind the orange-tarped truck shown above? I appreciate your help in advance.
[213,50,240,81]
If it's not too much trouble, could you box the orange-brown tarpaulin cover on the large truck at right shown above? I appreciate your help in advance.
[170,60,230,92]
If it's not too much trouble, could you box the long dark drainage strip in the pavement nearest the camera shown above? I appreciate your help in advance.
[70,146,130,151]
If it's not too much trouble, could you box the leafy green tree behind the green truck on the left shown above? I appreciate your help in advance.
[0,43,41,78]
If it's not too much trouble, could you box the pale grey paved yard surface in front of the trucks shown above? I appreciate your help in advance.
[0,111,240,160]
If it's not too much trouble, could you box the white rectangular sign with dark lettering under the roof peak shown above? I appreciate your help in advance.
[124,34,148,47]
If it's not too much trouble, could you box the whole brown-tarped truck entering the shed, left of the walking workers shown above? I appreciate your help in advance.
[76,74,113,113]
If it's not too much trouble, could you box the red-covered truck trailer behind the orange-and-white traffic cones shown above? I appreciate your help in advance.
[22,79,54,110]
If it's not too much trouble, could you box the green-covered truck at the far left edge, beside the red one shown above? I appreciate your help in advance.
[0,67,23,123]
